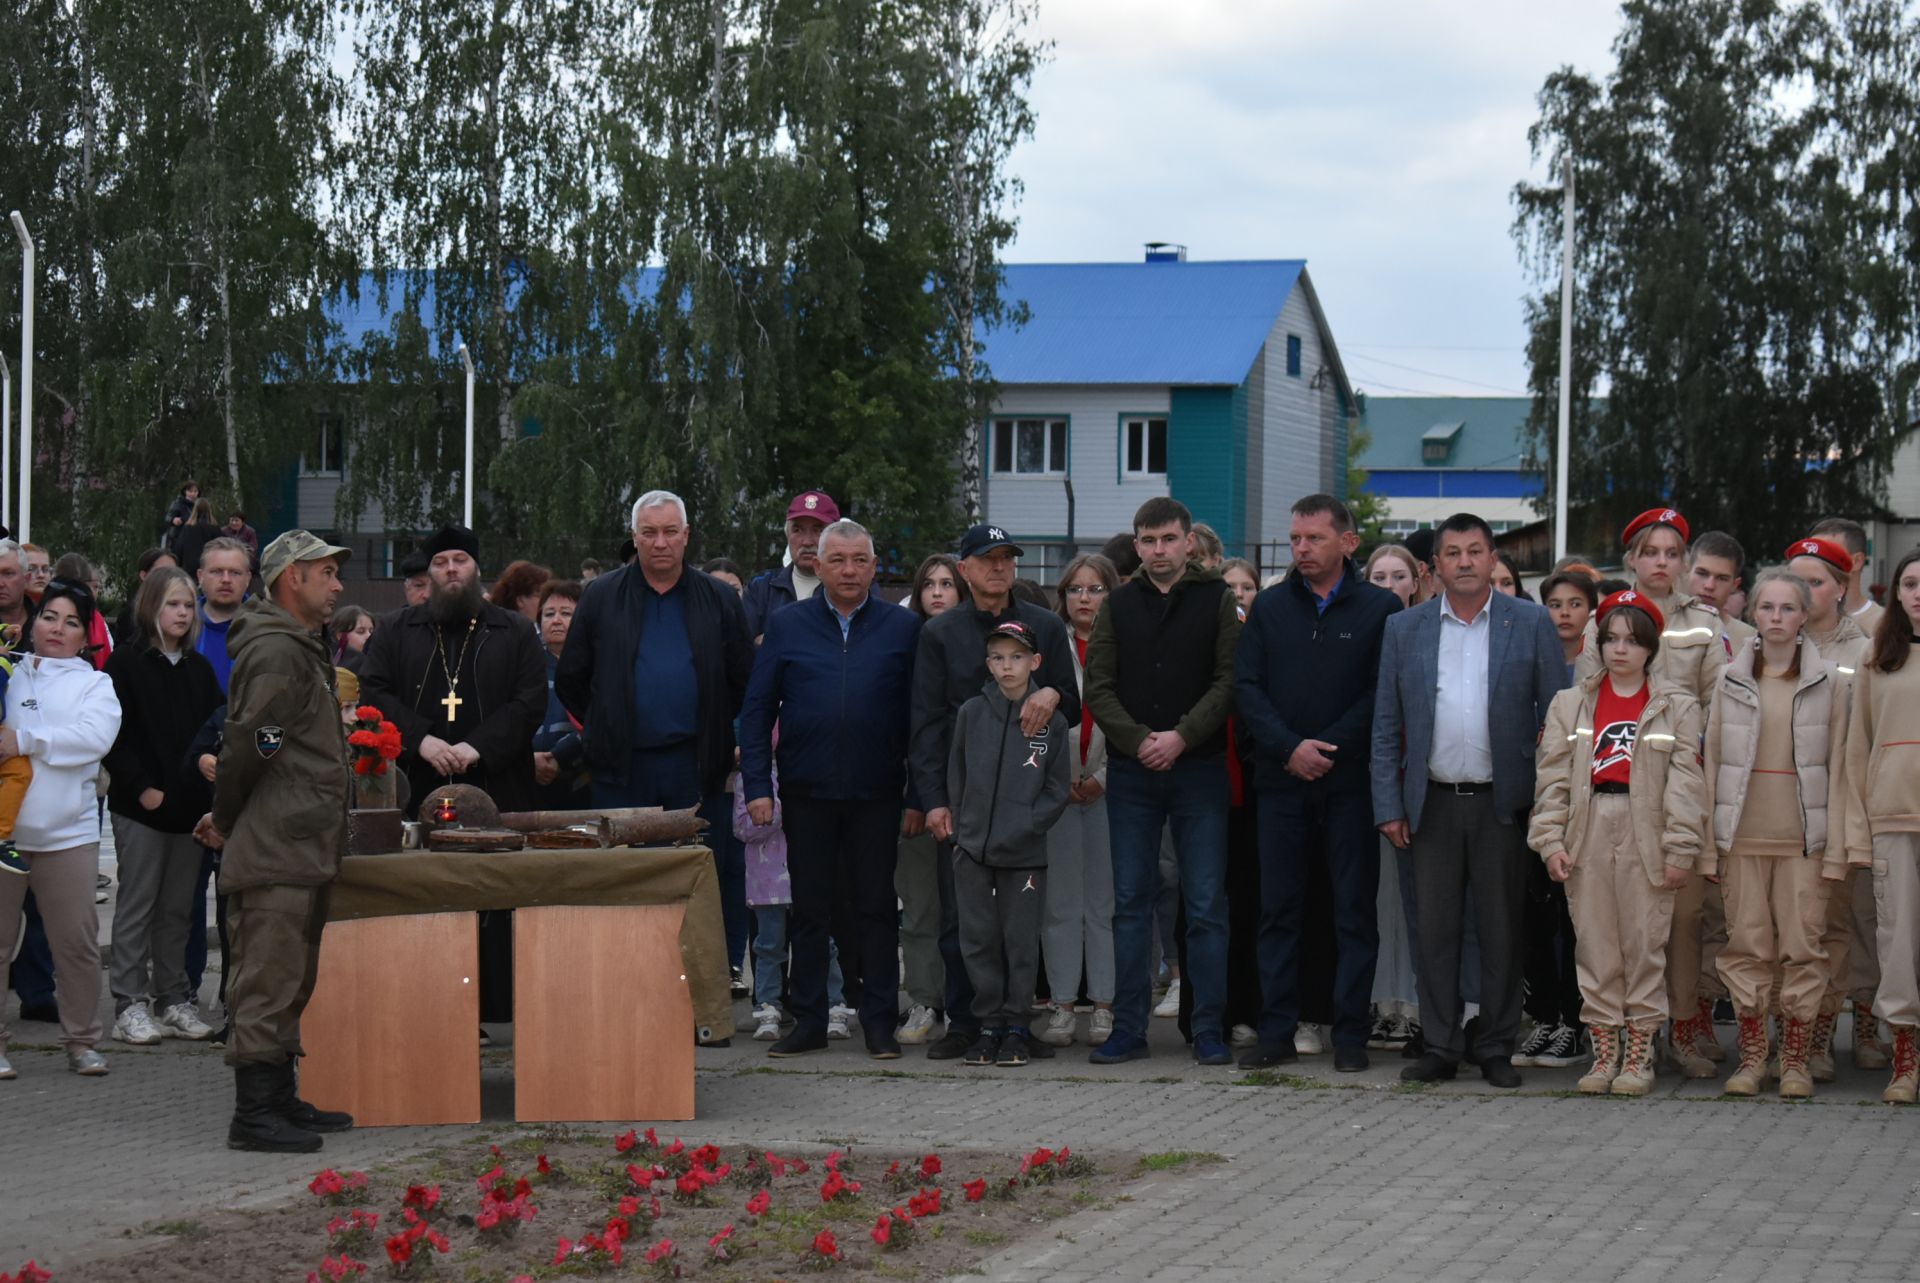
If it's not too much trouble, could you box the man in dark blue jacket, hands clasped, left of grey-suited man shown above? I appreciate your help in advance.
[1235,494,1400,1072]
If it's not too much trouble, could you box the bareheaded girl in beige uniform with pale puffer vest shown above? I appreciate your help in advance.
[1705,569,1849,1097]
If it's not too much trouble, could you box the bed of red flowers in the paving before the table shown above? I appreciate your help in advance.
[38,1129,1131,1283]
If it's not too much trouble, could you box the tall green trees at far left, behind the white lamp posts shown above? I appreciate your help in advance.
[0,0,349,567]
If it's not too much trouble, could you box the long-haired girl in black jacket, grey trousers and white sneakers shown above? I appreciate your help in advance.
[106,567,223,1043]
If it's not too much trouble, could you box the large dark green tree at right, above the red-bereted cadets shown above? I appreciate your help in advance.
[1515,0,1920,549]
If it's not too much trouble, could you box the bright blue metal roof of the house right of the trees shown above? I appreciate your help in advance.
[981,259,1306,386]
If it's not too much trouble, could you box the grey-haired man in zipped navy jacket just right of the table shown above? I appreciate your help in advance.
[739,520,920,1060]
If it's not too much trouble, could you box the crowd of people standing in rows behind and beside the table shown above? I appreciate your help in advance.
[0,480,1920,1147]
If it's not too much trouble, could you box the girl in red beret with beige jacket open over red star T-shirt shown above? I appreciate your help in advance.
[1526,592,1705,1097]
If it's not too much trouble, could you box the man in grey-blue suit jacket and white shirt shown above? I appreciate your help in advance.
[1373,513,1567,1087]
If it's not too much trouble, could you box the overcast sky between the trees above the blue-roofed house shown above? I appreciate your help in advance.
[1006,0,1619,396]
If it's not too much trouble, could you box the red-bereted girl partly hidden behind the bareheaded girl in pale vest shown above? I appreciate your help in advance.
[1786,536,1887,1083]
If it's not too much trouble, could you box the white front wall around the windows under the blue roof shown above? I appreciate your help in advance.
[985,384,1169,545]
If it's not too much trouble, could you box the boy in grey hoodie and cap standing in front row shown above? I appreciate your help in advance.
[947,620,1073,1066]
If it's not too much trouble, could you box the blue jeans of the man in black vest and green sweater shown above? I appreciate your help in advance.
[1106,755,1229,1041]
